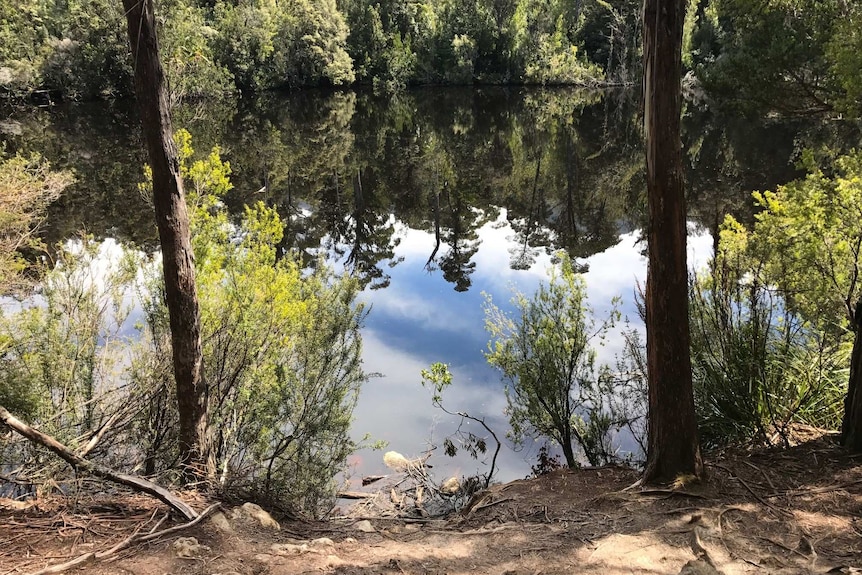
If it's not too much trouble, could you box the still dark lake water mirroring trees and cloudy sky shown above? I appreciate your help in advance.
[0,88,836,481]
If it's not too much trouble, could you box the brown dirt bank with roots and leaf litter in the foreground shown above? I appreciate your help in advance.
[0,436,862,575]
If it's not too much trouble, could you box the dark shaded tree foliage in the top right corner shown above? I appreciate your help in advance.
[700,0,859,113]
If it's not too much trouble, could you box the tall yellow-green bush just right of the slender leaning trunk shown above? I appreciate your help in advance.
[135,131,367,516]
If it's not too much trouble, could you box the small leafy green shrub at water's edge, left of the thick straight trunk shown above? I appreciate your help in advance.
[485,255,628,467]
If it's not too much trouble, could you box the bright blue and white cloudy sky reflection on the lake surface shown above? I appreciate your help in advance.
[351,211,712,488]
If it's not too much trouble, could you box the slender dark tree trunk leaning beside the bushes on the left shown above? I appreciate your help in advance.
[123,0,211,480]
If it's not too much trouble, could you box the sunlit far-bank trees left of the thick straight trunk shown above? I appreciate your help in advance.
[0,0,640,99]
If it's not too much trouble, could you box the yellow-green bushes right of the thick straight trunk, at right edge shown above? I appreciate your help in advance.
[691,152,862,445]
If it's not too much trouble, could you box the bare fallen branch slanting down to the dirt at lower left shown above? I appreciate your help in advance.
[0,406,198,521]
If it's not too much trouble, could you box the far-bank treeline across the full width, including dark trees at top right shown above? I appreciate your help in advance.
[0,0,862,116]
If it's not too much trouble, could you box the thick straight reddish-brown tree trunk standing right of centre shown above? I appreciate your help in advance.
[644,0,701,482]
